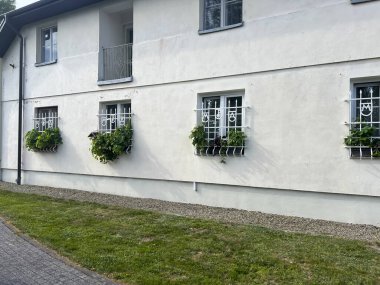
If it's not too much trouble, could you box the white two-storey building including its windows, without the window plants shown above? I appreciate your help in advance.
[0,0,380,226]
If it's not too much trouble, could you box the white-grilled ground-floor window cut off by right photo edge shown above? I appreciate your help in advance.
[345,82,380,158]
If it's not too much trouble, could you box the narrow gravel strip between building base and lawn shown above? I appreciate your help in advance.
[0,182,380,243]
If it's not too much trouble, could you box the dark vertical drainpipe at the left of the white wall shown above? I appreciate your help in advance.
[5,21,25,185]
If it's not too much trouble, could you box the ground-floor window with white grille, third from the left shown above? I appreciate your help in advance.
[197,94,247,155]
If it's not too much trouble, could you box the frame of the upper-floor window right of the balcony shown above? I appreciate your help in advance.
[199,0,244,34]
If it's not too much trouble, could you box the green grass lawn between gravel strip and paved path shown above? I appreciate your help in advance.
[0,191,380,285]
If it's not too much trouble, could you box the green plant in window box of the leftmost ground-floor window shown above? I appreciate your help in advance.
[25,128,62,151]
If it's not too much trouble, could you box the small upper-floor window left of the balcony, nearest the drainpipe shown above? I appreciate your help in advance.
[37,26,57,64]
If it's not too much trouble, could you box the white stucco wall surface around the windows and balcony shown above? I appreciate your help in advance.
[1,0,380,224]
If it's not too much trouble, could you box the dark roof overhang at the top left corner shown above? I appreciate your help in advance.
[0,0,105,58]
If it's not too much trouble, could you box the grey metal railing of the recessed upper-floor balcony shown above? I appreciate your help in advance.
[99,44,132,81]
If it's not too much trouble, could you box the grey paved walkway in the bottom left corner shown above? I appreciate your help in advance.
[0,220,114,285]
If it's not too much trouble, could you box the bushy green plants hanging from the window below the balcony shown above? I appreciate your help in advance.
[90,122,133,163]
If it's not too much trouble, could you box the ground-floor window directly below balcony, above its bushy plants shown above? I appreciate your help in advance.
[98,102,132,133]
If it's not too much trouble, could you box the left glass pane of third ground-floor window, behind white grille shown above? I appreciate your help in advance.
[201,97,221,145]
